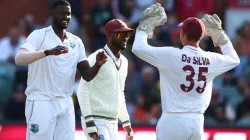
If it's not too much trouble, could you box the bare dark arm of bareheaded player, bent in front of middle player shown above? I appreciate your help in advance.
[77,51,107,82]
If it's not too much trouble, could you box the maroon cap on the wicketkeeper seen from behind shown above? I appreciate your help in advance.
[178,17,205,38]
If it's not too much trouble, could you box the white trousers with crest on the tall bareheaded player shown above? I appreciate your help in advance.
[25,97,75,140]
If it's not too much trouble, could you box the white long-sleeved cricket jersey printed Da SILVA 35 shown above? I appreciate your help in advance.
[132,31,240,113]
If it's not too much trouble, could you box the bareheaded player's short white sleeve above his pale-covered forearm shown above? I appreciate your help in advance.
[20,30,41,52]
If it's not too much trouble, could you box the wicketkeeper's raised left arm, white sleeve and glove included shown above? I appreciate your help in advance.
[132,3,173,69]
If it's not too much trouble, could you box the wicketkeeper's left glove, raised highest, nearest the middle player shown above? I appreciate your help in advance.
[137,3,167,38]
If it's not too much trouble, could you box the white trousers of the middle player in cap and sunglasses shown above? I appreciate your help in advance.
[81,117,118,140]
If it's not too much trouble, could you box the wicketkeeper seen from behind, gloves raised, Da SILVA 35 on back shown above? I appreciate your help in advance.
[132,4,240,140]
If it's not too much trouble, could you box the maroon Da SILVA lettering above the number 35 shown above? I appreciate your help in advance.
[181,54,210,66]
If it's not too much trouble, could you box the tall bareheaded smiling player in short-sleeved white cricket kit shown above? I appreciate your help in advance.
[15,0,107,140]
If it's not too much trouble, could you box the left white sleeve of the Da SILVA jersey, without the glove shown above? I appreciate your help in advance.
[132,31,176,69]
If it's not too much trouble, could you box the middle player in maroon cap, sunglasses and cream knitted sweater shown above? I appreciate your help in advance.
[77,19,134,140]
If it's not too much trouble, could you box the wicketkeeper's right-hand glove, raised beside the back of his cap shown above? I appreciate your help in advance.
[201,14,230,47]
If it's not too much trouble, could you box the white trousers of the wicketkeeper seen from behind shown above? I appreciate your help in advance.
[156,113,204,140]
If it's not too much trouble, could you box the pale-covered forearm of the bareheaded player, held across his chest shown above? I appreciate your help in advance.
[15,50,46,66]
